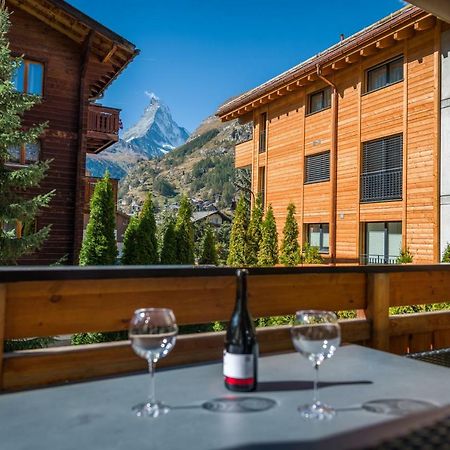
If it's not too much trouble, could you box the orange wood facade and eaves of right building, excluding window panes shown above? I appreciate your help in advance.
[218,7,449,263]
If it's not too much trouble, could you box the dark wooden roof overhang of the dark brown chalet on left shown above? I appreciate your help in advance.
[7,0,139,99]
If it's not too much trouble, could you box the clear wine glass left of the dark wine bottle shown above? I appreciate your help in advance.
[128,308,178,417]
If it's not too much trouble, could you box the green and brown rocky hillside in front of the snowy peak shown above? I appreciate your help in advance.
[119,116,252,214]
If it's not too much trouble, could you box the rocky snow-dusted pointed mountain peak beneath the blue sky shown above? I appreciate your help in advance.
[86,93,189,178]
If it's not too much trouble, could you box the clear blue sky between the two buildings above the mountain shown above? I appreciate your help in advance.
[68,0,404,131]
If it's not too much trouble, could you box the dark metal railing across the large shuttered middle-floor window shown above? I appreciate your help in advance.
[361,169,402,202]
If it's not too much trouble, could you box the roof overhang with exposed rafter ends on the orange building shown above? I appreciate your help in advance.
[216,5,434,122]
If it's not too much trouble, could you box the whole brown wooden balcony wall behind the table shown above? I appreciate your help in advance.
[0,265,450,391]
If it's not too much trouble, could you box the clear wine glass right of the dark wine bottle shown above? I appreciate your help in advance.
[291,310,341,420]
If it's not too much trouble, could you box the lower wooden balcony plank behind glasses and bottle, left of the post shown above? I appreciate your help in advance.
[4,320,369,391]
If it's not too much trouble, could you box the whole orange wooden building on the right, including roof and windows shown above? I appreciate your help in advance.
[217,6,450,263]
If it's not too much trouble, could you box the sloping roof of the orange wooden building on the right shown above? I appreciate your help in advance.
[216,5,429,120]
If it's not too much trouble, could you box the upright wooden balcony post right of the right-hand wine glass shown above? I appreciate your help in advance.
[365,273,390,351]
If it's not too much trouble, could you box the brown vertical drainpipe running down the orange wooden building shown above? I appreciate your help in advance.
[316,64,339,264]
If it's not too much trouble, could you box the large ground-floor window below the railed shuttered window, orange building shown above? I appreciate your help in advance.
[361,222,402,264]
